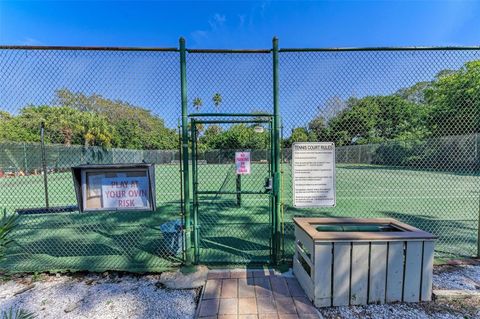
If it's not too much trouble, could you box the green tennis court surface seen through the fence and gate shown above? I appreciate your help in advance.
[0,164,480,272]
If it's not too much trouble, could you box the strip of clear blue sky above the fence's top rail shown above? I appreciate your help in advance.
[0,0,480,48]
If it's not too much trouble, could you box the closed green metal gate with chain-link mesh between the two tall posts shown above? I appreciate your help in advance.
[190,114,275,264]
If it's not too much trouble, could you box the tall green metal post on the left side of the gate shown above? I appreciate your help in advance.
[179,38,193,266]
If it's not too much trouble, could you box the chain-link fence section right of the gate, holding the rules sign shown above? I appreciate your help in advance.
[279,49,480,256]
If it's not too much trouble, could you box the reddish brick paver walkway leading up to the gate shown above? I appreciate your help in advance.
[197,270,320,319]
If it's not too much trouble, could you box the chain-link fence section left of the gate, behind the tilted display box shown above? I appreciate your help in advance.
[0,48,182,271]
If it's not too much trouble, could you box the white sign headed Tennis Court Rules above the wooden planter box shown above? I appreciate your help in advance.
[292,142,336,207]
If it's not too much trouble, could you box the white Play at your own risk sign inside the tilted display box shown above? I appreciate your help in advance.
[102,176,150,208]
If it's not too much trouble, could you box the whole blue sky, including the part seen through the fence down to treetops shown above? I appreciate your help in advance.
[0,0,480,132]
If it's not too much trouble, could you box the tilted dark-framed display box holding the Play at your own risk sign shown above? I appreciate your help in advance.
[72,163,156,212]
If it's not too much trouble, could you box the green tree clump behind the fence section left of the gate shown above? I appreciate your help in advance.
[0,89,178,149]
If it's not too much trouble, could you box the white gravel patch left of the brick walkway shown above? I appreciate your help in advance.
[0,275,197,319]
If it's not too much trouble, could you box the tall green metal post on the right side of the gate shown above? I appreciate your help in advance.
[272,37,282,264]
